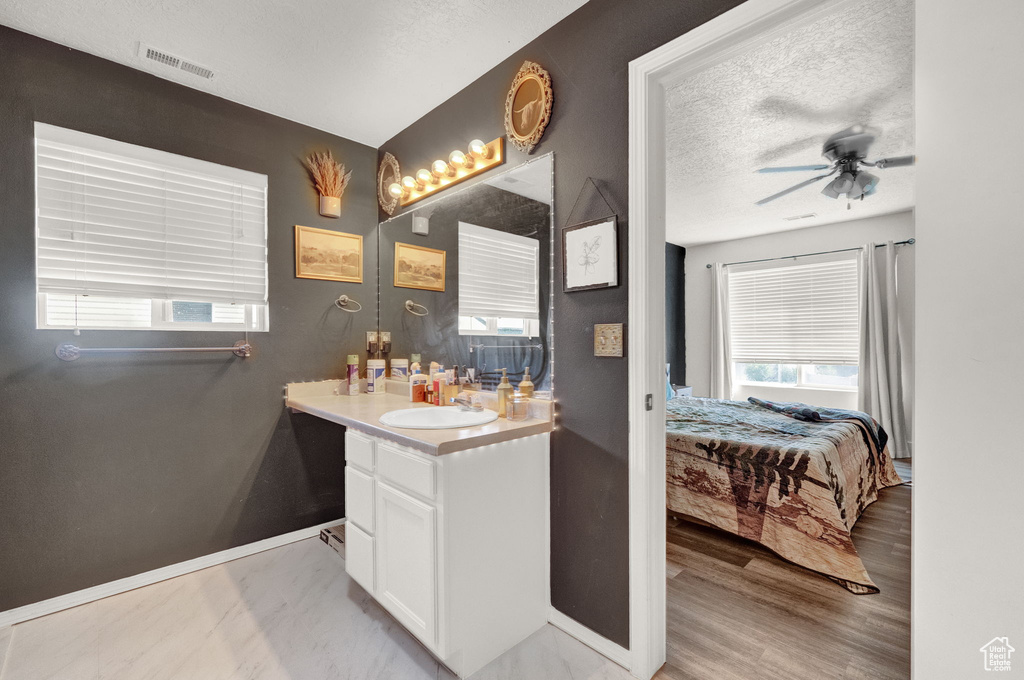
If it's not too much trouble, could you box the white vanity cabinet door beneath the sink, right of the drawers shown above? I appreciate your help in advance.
[376,481,437,649]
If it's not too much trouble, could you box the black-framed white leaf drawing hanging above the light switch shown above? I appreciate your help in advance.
[562,217,618,293]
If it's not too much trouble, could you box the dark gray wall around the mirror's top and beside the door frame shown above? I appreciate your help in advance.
[381,0,739,645]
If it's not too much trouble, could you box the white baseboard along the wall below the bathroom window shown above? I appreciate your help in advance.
[0,518,345,628]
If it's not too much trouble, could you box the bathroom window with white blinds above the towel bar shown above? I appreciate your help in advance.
[36,123,269,331]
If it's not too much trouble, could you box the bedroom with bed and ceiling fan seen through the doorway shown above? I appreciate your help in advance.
[665,0,915,679]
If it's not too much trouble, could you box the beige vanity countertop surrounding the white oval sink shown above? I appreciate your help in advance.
[285,380,552,456]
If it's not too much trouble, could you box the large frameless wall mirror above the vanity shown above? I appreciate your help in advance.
[378,154,554,396]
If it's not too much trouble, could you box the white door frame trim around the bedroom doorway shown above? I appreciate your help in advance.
[622,0,851,679]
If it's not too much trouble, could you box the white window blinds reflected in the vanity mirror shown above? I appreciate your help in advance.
[459,222,540,320]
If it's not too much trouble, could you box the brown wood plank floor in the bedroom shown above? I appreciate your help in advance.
[655,459,911,680]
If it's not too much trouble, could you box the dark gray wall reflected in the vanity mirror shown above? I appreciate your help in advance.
[378,184,551,390]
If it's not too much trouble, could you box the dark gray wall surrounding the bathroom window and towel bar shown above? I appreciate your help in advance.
[0,27,377,610]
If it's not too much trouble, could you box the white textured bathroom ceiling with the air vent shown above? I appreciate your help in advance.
[0,0,585,146]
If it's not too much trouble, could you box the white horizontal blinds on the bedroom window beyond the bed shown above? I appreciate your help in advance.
[727,253,859,365]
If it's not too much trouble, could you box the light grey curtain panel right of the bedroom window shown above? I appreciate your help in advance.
[857,241,910,458]
